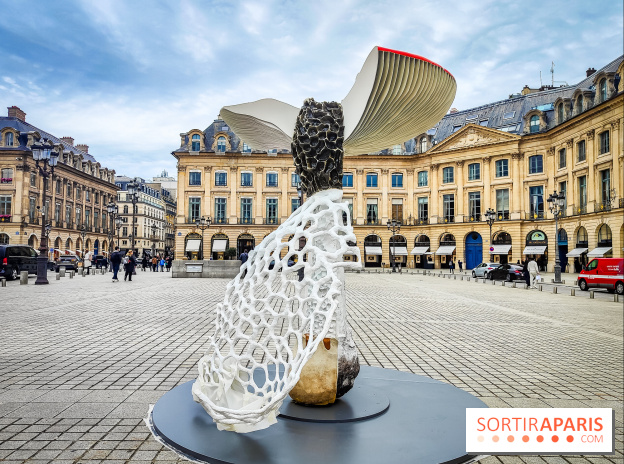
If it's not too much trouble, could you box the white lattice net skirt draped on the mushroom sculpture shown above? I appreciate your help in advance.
[193,189,361,433]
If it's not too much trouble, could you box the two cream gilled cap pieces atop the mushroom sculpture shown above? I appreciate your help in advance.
[221,47,457,155]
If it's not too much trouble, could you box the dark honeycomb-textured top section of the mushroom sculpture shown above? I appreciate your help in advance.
[291,98,344,196]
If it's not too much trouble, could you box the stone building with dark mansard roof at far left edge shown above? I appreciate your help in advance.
[0,106,116,259]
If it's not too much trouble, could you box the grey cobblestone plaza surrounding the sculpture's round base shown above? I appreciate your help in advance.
[0,271,623,464]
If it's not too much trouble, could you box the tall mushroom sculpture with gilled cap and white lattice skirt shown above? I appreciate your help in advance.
[192,47,456,433]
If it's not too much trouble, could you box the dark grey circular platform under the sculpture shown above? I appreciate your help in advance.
[151,366,487,464]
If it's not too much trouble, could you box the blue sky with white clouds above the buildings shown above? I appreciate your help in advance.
[0,0,623,178]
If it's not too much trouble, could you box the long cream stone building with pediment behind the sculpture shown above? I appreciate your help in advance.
[172,57,624,272]
